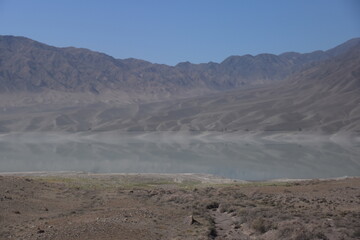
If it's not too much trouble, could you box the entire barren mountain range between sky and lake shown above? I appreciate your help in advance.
[0,36,360,133]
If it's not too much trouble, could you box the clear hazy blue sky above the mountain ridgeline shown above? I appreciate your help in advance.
[0,0,360,65]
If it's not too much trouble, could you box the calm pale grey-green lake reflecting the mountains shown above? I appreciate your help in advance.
[0,133,360,180]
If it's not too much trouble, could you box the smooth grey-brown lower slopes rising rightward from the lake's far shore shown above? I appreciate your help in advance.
[0,44,360,133]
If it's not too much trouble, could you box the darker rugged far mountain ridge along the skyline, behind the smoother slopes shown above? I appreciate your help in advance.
[0,36,360,104]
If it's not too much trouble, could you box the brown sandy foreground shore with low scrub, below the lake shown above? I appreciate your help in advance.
[0,174,360,240]
